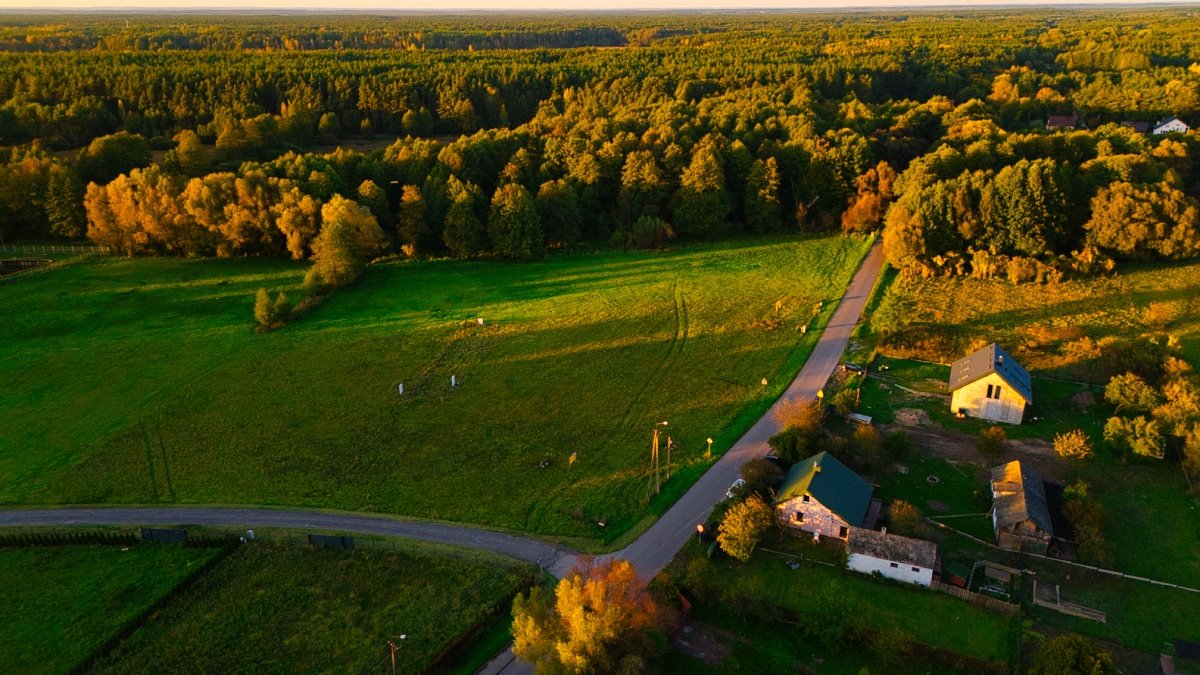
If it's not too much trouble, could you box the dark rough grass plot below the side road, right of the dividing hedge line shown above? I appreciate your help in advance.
[87,543,524,673]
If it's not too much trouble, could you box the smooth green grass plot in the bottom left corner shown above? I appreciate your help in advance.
[0,544,218,673]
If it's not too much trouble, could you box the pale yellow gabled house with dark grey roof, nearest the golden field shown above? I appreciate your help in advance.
[949,342,1033,424]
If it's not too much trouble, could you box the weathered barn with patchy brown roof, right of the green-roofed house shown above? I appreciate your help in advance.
[991,460,1054,554]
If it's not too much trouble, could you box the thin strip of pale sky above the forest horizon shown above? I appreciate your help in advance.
[9,0,1196,12]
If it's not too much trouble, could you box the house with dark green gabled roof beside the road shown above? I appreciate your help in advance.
[775,453,874,539]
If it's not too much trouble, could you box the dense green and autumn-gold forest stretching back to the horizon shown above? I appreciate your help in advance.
[0,8,1200,273]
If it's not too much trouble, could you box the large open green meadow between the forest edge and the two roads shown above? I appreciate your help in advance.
[0,237,869,539]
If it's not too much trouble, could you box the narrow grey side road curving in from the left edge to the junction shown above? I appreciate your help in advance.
[0,507,576,577]
